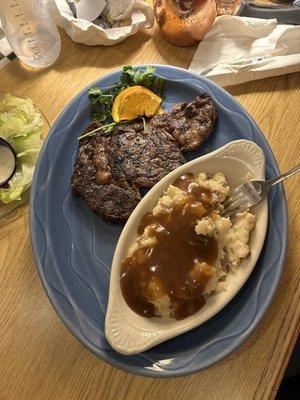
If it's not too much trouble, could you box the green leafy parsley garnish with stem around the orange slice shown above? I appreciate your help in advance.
[78,65,166,139]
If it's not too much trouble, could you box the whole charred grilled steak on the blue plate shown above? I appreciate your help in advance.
[72,95,217,223]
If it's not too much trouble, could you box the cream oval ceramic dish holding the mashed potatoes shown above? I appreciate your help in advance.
[105,140,268,355]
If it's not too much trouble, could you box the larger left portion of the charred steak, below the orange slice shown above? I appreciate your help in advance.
[72,122,184,223]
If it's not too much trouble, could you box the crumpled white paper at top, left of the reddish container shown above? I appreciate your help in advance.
[50,0,154,46]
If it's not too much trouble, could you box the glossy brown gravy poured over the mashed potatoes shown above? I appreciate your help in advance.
[120,173,218,320]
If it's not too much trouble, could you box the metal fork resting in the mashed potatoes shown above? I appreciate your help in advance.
[222,164,300,217]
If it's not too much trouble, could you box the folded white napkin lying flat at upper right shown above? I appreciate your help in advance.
[189,15,300,86]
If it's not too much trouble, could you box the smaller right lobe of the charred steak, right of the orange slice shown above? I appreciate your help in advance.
[150,93,217,151]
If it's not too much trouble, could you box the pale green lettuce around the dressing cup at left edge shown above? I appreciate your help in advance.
[0,94,44,203]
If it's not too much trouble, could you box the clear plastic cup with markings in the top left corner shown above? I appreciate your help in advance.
[0,0,61,67]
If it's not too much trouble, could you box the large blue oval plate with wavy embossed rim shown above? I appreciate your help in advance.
[30,65,287,377]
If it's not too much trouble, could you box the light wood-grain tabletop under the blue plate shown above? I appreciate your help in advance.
[0,24,300,400]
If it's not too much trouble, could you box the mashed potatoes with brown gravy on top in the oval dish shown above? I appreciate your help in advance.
[122,172,255,319]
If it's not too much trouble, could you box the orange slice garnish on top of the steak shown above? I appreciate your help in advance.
[112,86,162,122]
